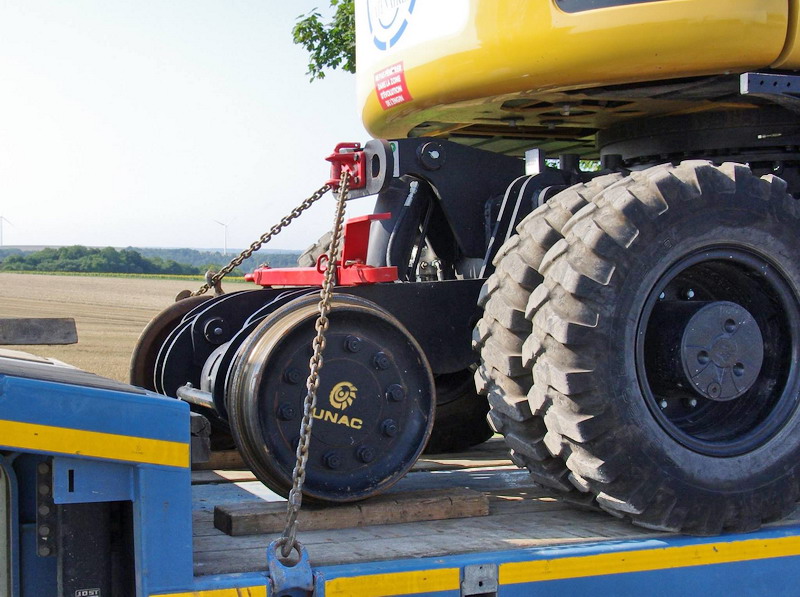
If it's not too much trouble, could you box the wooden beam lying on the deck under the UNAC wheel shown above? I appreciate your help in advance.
[214,488,489,536]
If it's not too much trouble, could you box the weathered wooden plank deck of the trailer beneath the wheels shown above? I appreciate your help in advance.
[192,438,800,576]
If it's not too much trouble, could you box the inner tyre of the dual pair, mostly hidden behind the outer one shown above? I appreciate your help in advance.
[473,174,622,488]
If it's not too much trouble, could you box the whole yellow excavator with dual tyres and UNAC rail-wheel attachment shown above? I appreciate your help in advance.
[131,0,800,534]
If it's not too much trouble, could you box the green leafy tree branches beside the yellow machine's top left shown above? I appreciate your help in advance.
[292,0,356,81]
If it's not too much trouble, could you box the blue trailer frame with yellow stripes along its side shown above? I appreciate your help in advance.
[0,357,800,597]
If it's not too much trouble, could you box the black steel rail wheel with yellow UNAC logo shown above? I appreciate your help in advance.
[226,295,435,502]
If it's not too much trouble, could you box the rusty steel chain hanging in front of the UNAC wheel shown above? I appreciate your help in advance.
[279,170,349,559]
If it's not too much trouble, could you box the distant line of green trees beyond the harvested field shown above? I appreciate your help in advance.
[0,245,299,276]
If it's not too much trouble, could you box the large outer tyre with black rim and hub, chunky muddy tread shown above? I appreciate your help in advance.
[531,161,800,535]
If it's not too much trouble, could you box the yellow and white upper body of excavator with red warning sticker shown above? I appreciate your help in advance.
[356,0,800,153]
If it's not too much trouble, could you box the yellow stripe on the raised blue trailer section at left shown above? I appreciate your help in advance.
[0,420,190,468]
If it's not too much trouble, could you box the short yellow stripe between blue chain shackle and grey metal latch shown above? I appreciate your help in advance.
[325,568,461,597]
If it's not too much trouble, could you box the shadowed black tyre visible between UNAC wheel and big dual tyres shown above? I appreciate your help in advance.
[425,369,492,454]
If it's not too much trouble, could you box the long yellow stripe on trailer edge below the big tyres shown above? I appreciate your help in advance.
[499,537,800,585]
